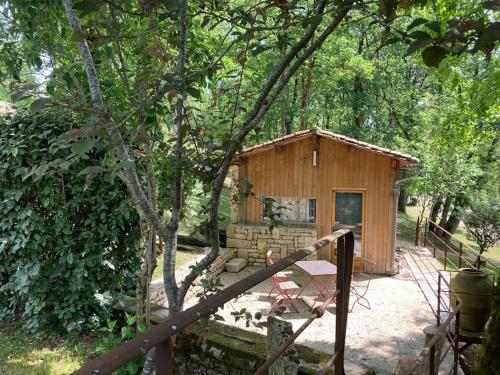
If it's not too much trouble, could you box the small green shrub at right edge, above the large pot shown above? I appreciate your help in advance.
[464,193,500,254]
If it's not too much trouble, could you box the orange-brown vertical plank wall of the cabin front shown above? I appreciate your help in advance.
[239,136,399,273]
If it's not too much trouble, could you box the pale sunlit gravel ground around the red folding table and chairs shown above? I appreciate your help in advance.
[197,266,434,374]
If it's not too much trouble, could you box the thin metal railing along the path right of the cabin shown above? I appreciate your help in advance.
[423,219,497,270]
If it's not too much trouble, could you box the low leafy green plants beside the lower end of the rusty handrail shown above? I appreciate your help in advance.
[95,313,146,375]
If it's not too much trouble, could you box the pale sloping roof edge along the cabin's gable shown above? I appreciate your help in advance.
[240,129,419,165]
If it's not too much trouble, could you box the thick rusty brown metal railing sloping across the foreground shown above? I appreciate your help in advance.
[73,229,354,375]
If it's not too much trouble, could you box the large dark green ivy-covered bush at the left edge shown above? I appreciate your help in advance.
[0,111,140,331]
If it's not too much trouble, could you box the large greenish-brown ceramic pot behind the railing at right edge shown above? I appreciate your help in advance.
[451,268,493,332]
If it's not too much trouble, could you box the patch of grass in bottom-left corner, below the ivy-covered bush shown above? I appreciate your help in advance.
[0,321,96,375]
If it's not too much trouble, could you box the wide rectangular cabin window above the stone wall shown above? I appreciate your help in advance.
[263,197,316,224]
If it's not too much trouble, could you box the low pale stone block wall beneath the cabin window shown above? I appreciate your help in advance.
[226,224,318,265]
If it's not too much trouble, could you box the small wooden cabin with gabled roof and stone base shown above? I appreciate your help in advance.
[227,129,418,274]
